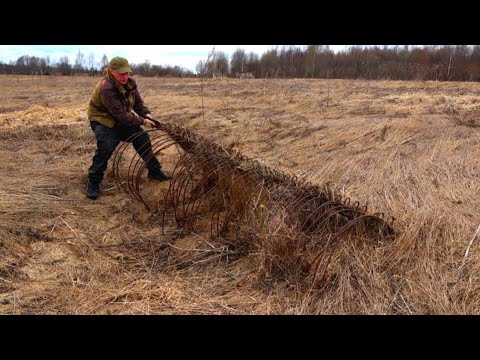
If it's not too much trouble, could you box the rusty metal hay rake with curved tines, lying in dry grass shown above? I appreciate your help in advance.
[113,122,395,281]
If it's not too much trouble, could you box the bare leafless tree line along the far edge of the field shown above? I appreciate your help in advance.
[0,45,480,81]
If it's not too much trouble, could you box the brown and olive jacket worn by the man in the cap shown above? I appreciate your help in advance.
[88,69,150,128]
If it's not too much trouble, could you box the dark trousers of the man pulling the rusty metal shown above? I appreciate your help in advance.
[88,121,161,184]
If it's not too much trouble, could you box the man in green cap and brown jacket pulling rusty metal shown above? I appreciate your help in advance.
[86,56,171,200]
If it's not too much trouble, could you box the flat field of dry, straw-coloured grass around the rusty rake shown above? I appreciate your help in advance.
[0,76,480,314]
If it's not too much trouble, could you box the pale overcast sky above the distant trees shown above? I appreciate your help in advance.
[0,45,345,72]
